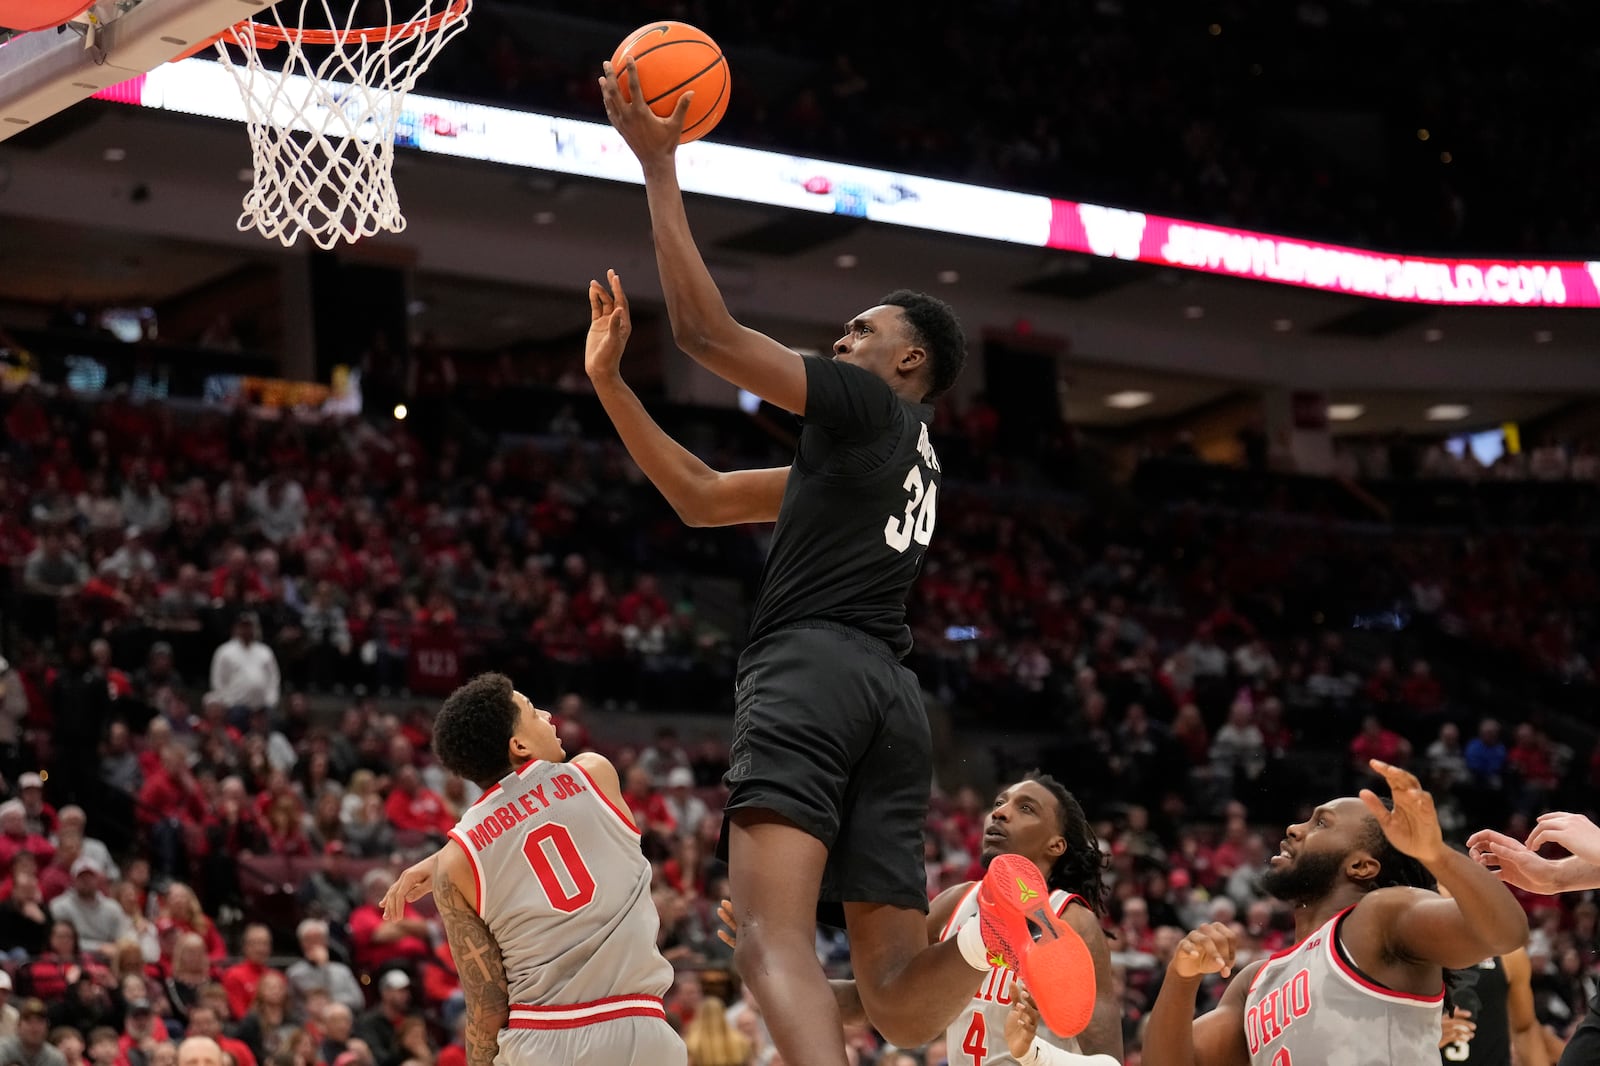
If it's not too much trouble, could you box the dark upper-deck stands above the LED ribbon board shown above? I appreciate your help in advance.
[427,0,1600,256]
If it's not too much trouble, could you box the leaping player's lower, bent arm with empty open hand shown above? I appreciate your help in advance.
[584,271,789,525]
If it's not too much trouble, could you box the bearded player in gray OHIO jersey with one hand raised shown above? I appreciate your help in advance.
[1144,759,1528,1066]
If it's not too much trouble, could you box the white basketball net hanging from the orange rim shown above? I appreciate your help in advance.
[218,0,472,248]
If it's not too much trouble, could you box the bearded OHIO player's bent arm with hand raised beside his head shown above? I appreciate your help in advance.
[1350,759,1528,970]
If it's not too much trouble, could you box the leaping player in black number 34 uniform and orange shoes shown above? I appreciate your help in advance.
[601,64,1094,1066]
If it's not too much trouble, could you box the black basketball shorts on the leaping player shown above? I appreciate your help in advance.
[717,621,933,927]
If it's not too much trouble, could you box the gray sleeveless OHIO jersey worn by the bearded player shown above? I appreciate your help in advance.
[1245,908,1445,1066]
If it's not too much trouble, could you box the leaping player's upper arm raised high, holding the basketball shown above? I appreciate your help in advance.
[600,59,806,415]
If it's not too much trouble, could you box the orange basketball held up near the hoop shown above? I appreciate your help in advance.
[611,22,733,144]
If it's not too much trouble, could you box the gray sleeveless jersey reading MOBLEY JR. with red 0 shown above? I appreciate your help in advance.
[450,760,672,1029]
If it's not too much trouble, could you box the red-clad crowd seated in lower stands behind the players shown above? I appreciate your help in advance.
[0,376,1600,1066]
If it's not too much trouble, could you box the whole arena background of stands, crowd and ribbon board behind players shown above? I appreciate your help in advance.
[0,0,1600,1066]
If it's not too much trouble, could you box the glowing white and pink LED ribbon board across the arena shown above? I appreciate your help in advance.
[96,59,1600,307]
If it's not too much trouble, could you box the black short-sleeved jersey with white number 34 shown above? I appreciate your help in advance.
[750,357,939,656]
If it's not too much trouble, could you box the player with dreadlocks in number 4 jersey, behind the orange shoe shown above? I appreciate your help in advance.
[718,770,1120,1066]
